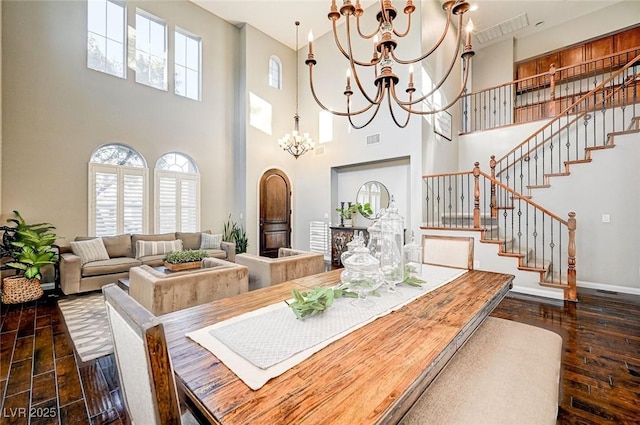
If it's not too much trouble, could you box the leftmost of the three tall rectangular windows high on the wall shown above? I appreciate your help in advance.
[87,0,126,78]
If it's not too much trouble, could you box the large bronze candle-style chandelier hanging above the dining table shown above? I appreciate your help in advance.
[305,0,475,129]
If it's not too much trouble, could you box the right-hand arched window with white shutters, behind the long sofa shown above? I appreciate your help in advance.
[155,152,200,233]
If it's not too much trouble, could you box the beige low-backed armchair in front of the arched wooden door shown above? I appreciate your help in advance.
[236,248,324,291]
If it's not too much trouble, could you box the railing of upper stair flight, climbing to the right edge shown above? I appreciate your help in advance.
[491,54,640,195]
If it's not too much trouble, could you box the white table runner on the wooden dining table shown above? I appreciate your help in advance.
[186,265,466,390]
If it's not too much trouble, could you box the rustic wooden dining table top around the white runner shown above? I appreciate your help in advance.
[160,269,513,425]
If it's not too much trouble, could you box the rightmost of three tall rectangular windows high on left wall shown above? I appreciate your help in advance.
[175,28,201,100]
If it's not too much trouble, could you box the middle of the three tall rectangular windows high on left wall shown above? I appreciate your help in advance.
[136,9,167,90]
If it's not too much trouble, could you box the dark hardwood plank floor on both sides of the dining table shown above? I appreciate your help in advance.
[0,284,640,425]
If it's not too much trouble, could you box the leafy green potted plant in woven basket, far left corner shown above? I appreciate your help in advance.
[0,210,58,304]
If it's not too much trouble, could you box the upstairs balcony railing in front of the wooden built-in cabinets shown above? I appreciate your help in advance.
[460,47,640,133]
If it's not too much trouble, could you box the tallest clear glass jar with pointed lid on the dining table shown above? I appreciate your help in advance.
[380,195,404,292]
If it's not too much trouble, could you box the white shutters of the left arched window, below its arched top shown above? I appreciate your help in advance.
[89,163,148,236]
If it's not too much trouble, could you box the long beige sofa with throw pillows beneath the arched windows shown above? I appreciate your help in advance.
[60,232,236,295]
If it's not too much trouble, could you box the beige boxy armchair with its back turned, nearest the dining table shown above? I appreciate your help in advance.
[129,258,249,316]
